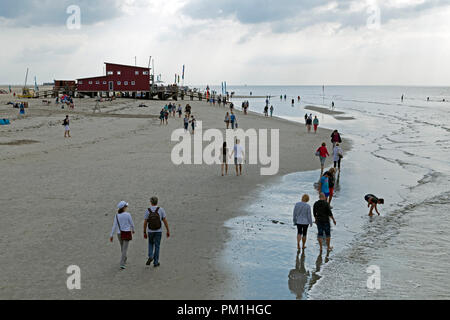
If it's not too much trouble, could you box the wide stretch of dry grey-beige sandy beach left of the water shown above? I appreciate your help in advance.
[0,90,348,299]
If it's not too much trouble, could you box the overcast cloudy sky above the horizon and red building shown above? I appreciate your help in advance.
[0,0,450,86]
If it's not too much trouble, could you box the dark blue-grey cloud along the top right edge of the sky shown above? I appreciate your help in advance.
[183,0,450,33]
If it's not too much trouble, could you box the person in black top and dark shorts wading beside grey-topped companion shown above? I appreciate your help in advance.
[313,193,336,254]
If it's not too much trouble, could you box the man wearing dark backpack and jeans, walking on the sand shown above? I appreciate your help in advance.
[144,197,170,268]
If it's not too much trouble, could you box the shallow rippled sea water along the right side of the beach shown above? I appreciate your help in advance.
[213,86,450,299]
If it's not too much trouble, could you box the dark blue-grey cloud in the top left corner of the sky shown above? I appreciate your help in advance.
[0,0,121,27]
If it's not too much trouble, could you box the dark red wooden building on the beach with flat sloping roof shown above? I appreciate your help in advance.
[77,62,150,95]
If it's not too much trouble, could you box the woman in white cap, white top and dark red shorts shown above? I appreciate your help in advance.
[109,201,134,270]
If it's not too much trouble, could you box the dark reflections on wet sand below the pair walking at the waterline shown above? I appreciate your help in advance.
[288,251,330,300]
